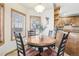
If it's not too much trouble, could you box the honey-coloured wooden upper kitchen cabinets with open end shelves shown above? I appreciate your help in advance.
[54,4,79,28]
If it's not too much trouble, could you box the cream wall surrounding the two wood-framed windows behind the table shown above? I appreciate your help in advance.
[4,3,54,43]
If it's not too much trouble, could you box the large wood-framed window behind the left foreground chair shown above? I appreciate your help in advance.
[11,9,26,40]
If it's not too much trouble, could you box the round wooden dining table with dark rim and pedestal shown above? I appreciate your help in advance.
[27,36,56,52]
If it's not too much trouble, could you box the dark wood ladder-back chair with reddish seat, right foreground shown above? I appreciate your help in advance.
[41,32,70,56]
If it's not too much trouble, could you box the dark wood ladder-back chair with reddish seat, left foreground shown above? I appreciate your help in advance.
[14,32,39,56]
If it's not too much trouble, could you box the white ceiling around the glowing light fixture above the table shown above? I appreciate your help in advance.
[21,3,53,9]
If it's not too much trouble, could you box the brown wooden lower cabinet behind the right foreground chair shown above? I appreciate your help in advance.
[65,33,79,56]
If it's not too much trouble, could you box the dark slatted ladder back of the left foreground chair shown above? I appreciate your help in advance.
[14,32,26,56]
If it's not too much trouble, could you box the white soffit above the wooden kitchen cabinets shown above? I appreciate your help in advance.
[60,3,79,17]
